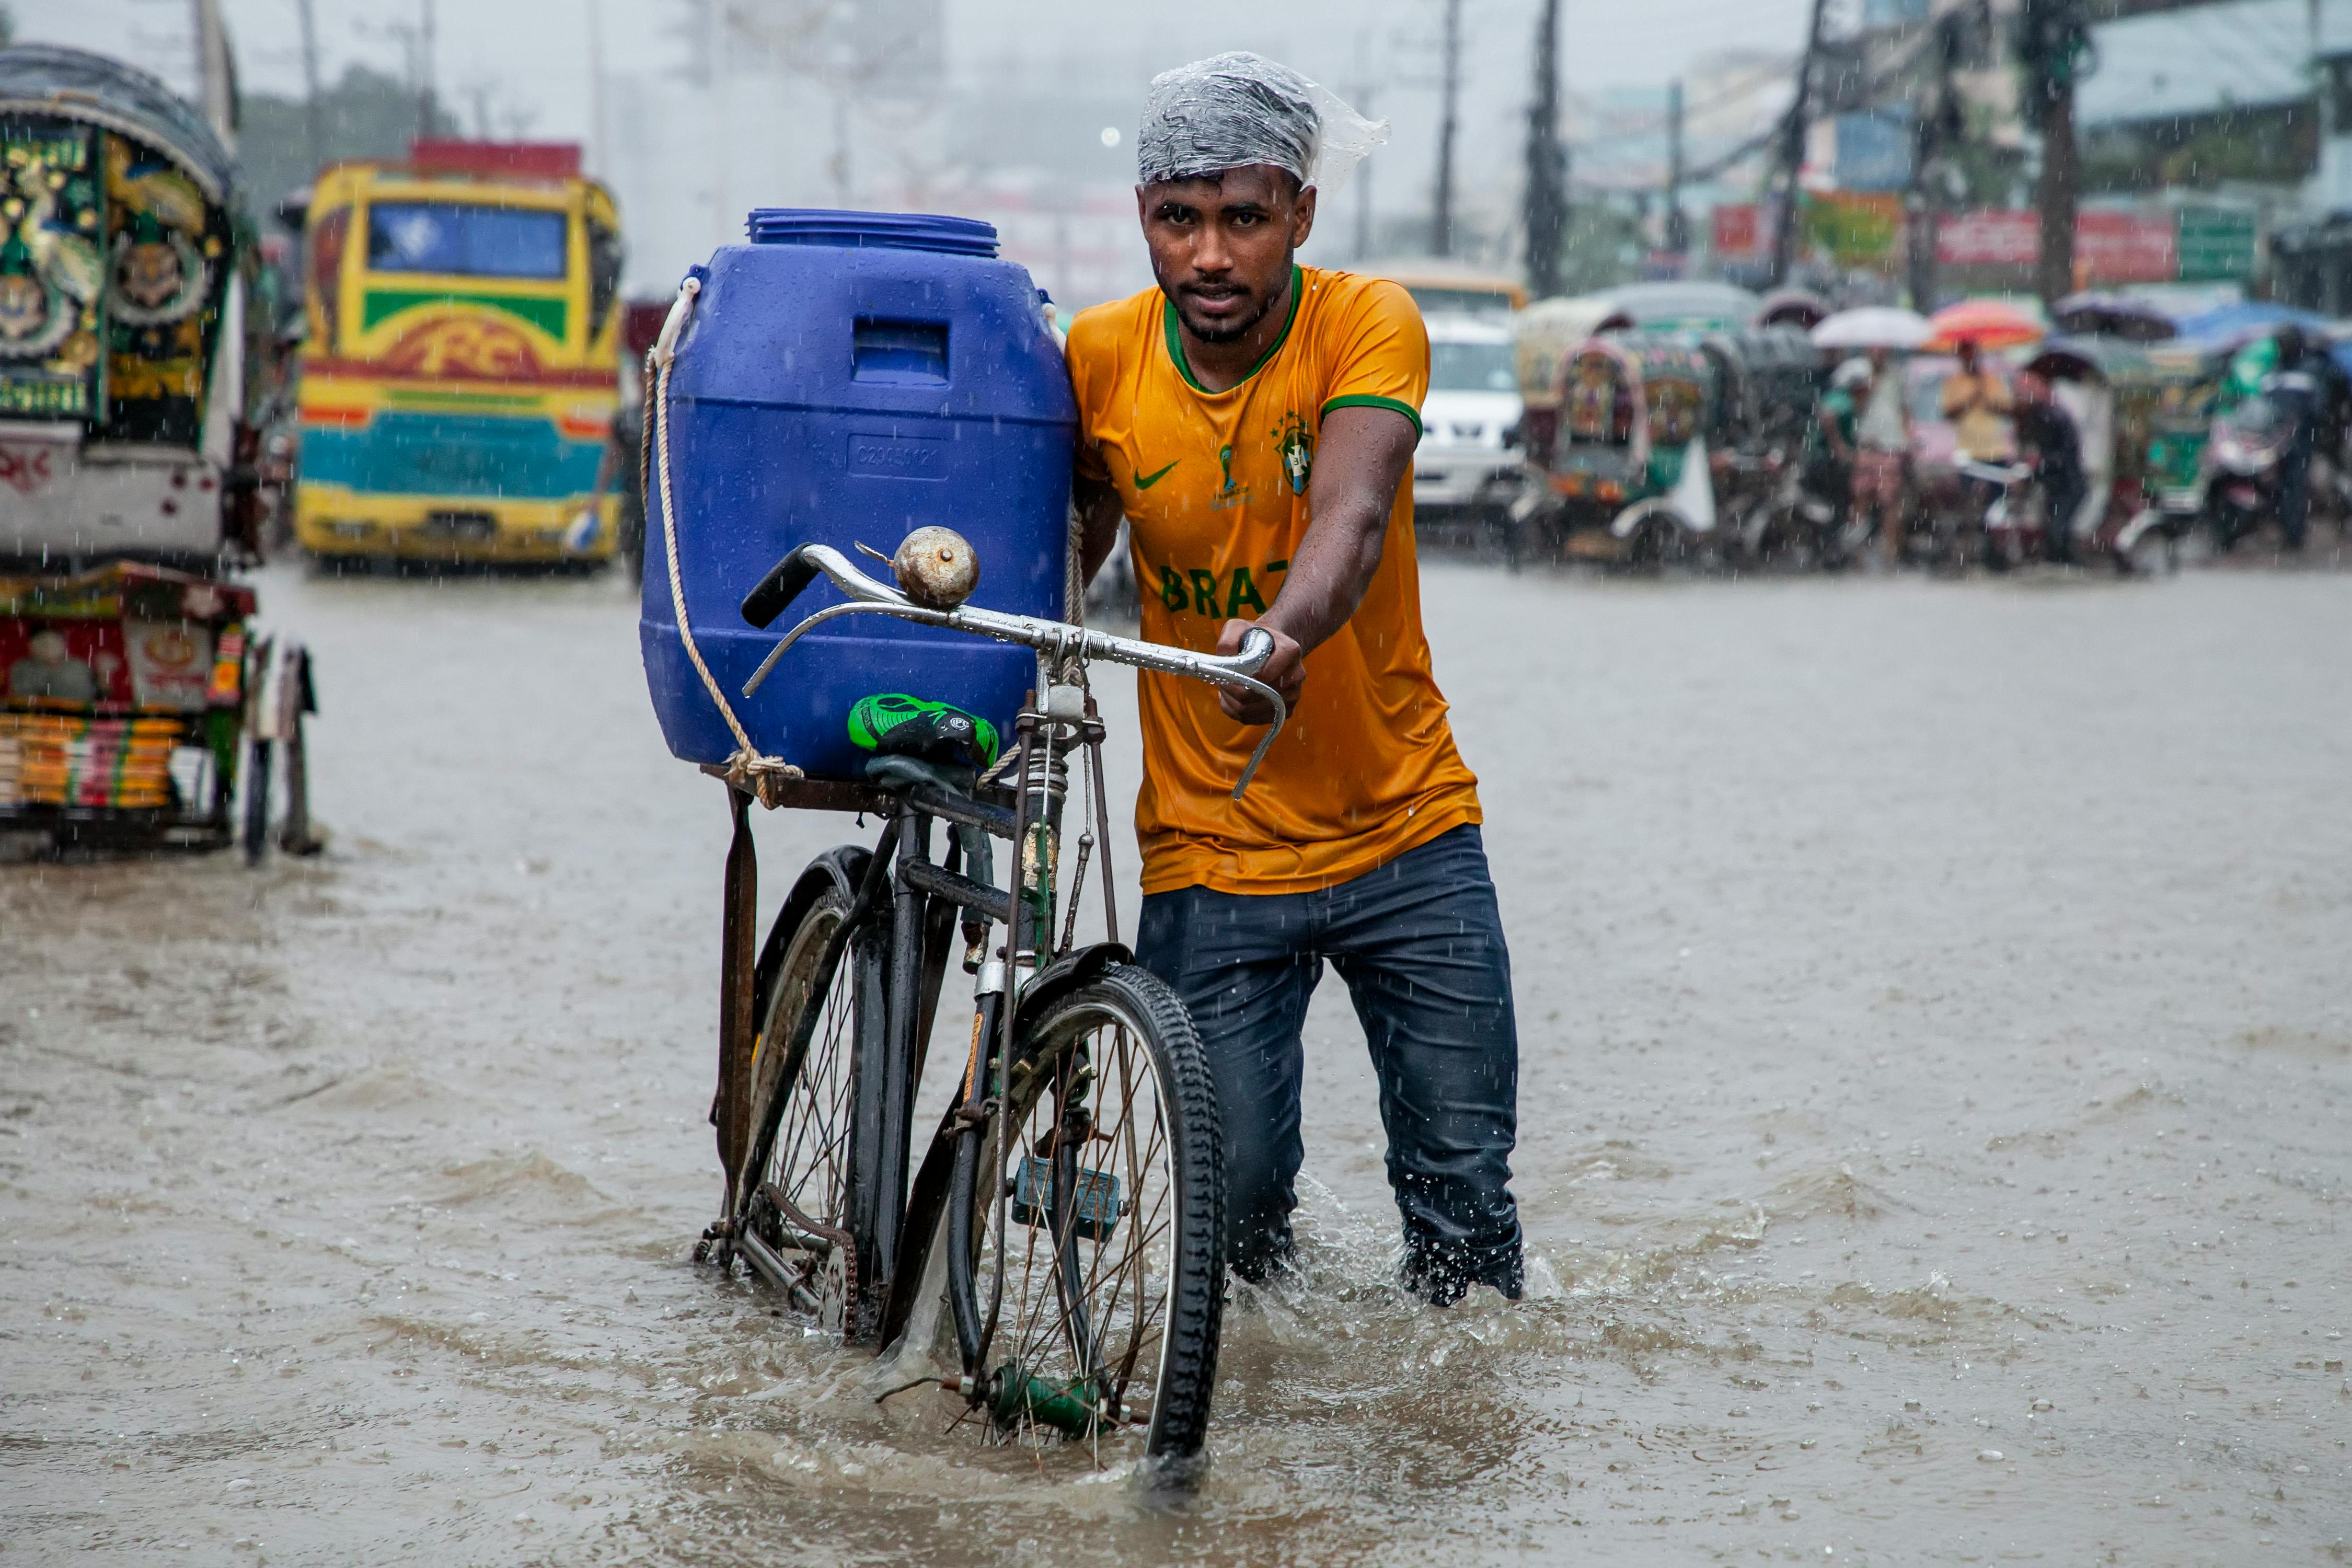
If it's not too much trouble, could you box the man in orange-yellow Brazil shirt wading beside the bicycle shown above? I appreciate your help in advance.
[1070,54,1522,1305]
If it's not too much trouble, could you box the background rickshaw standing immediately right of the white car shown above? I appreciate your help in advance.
[1513,331,1720,567]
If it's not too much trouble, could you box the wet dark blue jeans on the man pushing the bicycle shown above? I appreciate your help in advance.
[1136,825,1522,1305]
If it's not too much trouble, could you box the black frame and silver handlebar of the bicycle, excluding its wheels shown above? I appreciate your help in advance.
[708,545,1287,1422]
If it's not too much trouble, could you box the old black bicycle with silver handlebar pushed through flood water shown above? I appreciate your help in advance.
[696,540,1287,1460]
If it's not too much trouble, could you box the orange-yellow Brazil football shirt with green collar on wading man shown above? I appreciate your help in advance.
[1068,268,1480,893]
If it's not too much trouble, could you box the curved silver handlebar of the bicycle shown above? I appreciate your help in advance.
[743,545,1289,799]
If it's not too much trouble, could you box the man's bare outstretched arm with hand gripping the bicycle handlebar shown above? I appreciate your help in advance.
[1216,407,1419,724]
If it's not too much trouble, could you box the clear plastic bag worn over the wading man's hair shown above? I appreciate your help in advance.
[1136,54,1388,190]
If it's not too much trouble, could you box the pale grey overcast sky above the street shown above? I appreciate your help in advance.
[0,0,1816,303]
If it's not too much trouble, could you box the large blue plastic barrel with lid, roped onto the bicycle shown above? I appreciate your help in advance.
[638,207,1077,778]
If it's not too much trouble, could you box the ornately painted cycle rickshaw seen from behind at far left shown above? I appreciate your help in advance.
[0,47,313,856]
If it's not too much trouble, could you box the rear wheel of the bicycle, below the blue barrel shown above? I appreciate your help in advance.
[736,868,892,1333]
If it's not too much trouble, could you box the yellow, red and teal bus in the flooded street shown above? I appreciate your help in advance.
[294,141,621,562]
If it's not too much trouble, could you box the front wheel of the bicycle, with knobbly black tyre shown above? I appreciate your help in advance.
[976,964,1226,1458]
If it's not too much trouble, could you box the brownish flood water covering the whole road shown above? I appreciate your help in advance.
[0,564,2352,1563]
